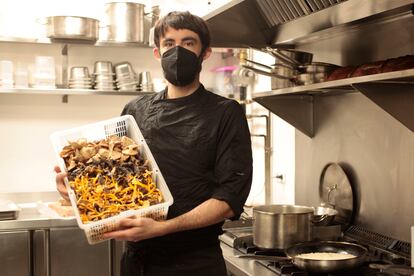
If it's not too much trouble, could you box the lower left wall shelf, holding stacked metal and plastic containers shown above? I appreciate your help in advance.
[0,88,156,96]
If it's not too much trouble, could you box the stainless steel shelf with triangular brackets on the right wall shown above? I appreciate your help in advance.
[253,69,414,137]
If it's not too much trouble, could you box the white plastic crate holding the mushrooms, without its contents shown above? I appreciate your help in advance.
[51,115,173,244]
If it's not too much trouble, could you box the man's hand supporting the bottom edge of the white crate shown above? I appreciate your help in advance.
[103,217,166,242]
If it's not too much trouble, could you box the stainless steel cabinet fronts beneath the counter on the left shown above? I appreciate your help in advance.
[0,227,124,276]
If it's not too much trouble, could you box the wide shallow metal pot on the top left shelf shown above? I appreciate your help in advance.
[46,16,99,42]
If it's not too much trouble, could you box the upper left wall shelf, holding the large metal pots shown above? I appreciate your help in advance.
[0,36,150,48]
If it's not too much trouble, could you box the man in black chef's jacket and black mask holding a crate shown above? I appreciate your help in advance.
[55,12,252,276]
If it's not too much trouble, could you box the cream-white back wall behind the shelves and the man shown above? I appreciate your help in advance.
[0,0,294,206]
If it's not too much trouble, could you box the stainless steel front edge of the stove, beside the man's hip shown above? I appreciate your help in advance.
[221,242,276,276]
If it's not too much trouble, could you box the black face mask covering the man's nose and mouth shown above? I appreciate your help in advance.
[161,46,202,86]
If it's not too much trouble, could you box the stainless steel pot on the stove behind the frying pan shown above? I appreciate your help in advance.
[253,205,314,249]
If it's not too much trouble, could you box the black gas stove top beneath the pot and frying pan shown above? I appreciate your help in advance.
[220,225,414,276]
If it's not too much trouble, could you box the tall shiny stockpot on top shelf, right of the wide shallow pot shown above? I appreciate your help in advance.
[105,2,145,43]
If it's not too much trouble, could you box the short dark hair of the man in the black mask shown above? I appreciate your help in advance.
[154,11,210,53]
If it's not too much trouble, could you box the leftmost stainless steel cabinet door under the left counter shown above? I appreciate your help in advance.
[0,231,31,276]
